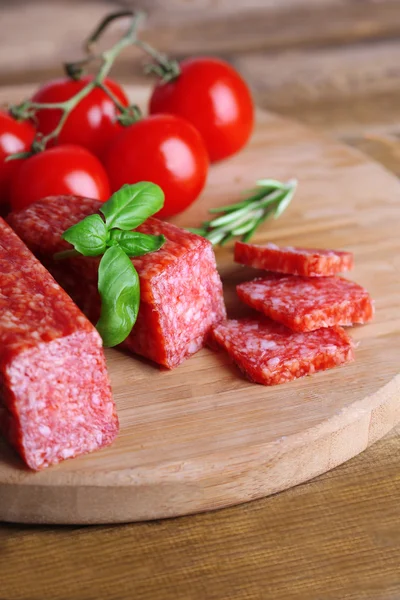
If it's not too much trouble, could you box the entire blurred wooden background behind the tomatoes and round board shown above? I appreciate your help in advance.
[0,0,400,173]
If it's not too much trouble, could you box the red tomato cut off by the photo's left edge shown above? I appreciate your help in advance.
[0,111,35,205]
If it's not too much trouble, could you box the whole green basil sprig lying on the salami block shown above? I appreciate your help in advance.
[54,181,165,347]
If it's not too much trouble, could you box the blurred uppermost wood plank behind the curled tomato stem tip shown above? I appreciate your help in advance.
[0,0,400,82]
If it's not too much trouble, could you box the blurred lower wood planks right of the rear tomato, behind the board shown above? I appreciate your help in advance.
[234,48,400,184]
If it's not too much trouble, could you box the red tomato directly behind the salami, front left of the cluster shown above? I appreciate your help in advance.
[10,144,110,210]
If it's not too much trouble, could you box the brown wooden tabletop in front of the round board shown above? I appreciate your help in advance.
[0,429,400,600]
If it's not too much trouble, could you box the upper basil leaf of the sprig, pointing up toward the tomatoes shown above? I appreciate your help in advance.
[100,181,164,231]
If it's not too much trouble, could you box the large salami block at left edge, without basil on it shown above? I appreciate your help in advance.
[0,219,118,470]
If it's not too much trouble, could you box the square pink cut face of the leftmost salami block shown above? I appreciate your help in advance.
[4,331,118,470]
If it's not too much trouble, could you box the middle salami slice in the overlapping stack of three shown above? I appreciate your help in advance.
[236,275,374,331]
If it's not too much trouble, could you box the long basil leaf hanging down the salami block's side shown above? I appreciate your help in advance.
[96,246,140,347]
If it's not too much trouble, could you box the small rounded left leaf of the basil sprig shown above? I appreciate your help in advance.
[62,215,107,256]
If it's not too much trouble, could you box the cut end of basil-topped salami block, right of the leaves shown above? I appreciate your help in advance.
[124,219,226,369]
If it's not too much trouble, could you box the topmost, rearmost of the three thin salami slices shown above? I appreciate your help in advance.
[235,242,353,277]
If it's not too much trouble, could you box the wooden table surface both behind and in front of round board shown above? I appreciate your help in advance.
[0,0,400,600]
